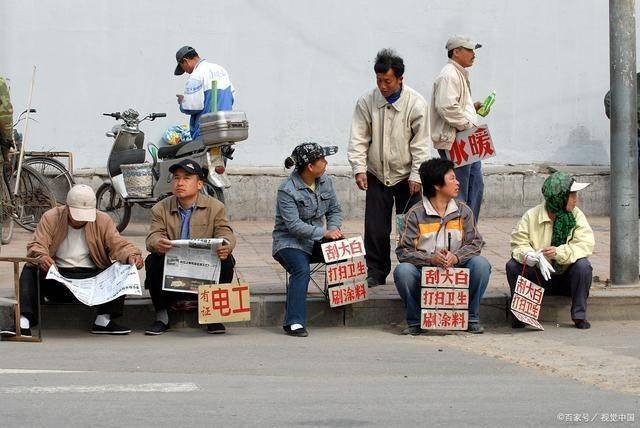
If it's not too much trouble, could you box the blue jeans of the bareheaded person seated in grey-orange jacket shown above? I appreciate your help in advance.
[393,256,491,326]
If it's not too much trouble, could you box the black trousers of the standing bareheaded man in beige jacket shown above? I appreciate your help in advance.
[364,172,422,284]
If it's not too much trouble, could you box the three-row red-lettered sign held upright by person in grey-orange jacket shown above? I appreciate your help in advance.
[420,266,469,330]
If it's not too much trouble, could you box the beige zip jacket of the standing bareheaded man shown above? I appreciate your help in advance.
[347,85,431,186]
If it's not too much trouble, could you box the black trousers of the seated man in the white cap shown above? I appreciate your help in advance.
[20,265,125,326]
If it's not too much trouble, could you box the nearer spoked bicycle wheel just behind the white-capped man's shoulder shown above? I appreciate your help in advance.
[9,165,56,232]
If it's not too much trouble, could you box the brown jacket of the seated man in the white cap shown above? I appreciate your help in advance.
[27,205,141,269]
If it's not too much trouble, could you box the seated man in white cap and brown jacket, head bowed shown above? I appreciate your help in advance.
[3,184,143,336]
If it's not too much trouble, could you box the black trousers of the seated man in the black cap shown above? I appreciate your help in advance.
[144,253,236,311]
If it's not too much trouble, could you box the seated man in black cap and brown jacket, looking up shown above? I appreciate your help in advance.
[145,159,236,335]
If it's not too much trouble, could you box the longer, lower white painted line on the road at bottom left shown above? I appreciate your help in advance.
[0,383,199,394]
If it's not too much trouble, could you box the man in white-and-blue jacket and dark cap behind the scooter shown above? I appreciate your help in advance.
[173,46,235,139]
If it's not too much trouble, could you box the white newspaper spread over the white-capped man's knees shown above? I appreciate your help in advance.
[47,262,142,306]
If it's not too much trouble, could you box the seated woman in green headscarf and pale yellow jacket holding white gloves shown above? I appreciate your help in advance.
[506,171,594,329]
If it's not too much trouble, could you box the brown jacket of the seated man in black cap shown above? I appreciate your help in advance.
[146,193,236,253]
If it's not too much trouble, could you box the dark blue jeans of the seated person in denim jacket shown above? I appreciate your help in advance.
[273,248,311,326]
